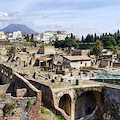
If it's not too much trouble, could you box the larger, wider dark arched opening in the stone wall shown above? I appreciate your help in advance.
[75,90,102,120]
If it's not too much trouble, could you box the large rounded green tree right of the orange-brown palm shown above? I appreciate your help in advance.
[102,36,117,51]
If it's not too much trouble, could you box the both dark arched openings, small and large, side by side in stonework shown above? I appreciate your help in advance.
[59,91,102,120]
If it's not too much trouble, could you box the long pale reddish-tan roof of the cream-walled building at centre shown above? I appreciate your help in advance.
[64,56,91,61]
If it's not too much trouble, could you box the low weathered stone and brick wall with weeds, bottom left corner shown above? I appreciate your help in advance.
[0,93,40,120]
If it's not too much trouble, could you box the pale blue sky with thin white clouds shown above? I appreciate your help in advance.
[0,0,120,37]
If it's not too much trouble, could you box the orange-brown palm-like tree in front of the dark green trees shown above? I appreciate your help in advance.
[93,40,103,58]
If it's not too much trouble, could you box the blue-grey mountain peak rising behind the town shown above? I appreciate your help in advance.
[0,24,37,34]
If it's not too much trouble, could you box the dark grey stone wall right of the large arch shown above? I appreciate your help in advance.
[103,87,120,120]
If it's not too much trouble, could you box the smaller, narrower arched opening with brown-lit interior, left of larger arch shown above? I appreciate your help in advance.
[59,94,72,116]
